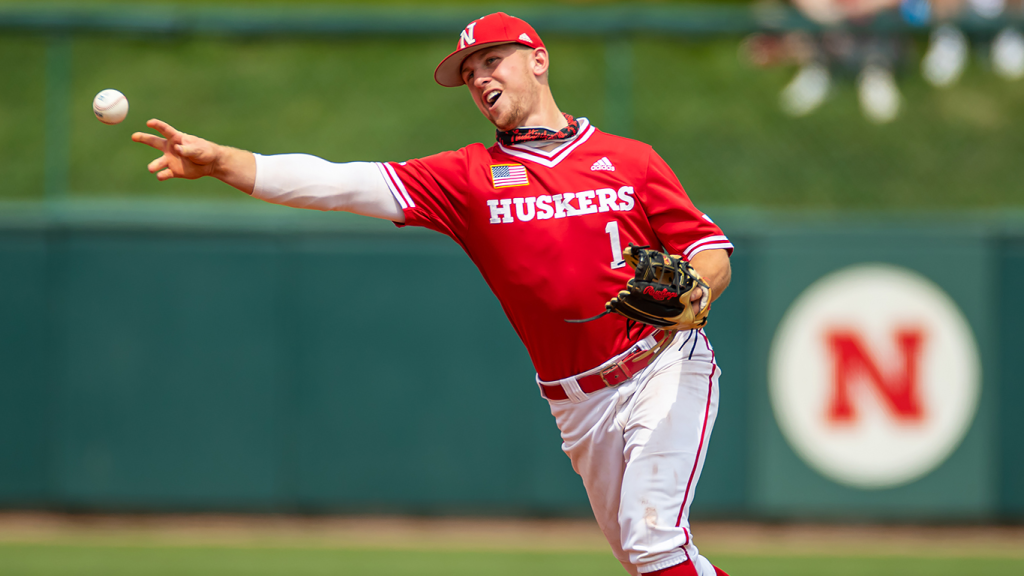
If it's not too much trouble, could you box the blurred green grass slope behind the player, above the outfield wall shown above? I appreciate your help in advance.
[0,24,1024,209]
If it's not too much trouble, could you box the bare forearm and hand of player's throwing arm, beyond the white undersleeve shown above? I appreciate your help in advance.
[131,118,256,194]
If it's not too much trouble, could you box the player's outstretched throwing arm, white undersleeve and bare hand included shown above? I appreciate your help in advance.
[132,119,406,222]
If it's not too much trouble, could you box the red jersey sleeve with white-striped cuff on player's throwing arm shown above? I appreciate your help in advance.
[377,149,468,241]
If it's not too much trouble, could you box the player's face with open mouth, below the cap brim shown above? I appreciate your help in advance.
[462,44,539,130]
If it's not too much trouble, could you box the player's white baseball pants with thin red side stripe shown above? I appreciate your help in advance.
[546,330,720,576]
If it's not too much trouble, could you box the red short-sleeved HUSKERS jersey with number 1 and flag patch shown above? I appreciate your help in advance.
[379,118,732,381]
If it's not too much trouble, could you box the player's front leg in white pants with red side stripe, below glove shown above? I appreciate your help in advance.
[620,354,719,572]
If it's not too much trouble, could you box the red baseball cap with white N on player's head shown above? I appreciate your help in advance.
[434,12,544,88]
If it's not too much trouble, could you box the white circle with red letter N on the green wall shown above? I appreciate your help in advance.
[768,263,981,489]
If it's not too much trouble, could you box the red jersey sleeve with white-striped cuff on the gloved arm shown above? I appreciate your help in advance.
[639,151,732,260]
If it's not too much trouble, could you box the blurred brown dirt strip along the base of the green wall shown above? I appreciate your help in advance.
[0,512,1024,559]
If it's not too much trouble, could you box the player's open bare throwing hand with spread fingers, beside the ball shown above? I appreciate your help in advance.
[131,118,221,181]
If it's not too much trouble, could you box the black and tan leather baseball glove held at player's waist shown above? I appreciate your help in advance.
[568,244,711,330]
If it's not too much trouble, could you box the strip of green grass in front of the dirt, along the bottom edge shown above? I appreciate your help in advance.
[0,544,1024,576]
